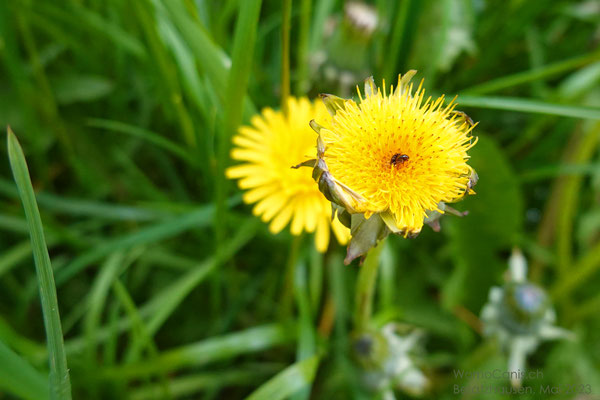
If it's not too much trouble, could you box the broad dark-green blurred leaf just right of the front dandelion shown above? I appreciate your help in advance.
[441,136,524,313]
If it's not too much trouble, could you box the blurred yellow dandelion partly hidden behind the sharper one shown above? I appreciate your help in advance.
[226,97,350,252]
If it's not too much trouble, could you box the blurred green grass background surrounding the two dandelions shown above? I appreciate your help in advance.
[0,0,600,400]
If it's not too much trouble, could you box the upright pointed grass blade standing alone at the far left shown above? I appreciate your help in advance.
[7,128,71,400]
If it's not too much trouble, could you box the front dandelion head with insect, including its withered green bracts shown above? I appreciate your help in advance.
[298,71,478,263]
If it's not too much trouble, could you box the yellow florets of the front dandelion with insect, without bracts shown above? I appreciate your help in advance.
[317,73,476,234]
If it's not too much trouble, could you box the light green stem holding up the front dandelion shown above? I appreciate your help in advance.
[354,241,385,330]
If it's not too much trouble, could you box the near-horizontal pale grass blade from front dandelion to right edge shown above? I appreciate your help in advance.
[458,95,600,120]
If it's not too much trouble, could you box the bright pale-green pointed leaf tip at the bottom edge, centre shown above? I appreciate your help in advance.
[246,355,320,400]
